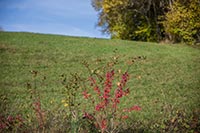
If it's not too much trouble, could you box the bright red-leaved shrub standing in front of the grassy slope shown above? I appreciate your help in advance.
[82,58,141,133]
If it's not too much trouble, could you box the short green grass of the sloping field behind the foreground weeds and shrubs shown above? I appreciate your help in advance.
[0,32,200,132]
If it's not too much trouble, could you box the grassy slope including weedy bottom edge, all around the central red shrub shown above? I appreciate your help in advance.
[0,32,200,132]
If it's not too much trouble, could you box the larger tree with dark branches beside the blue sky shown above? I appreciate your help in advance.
[92,0,172,41]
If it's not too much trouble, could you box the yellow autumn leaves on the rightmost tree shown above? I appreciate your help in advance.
[163,0,200,43]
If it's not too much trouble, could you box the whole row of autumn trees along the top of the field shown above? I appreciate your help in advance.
[92,0,200,44]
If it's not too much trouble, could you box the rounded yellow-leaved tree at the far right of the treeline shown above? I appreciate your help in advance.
[164,0,200,44]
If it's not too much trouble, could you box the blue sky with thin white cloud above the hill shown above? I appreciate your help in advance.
[0,0,109,38]
